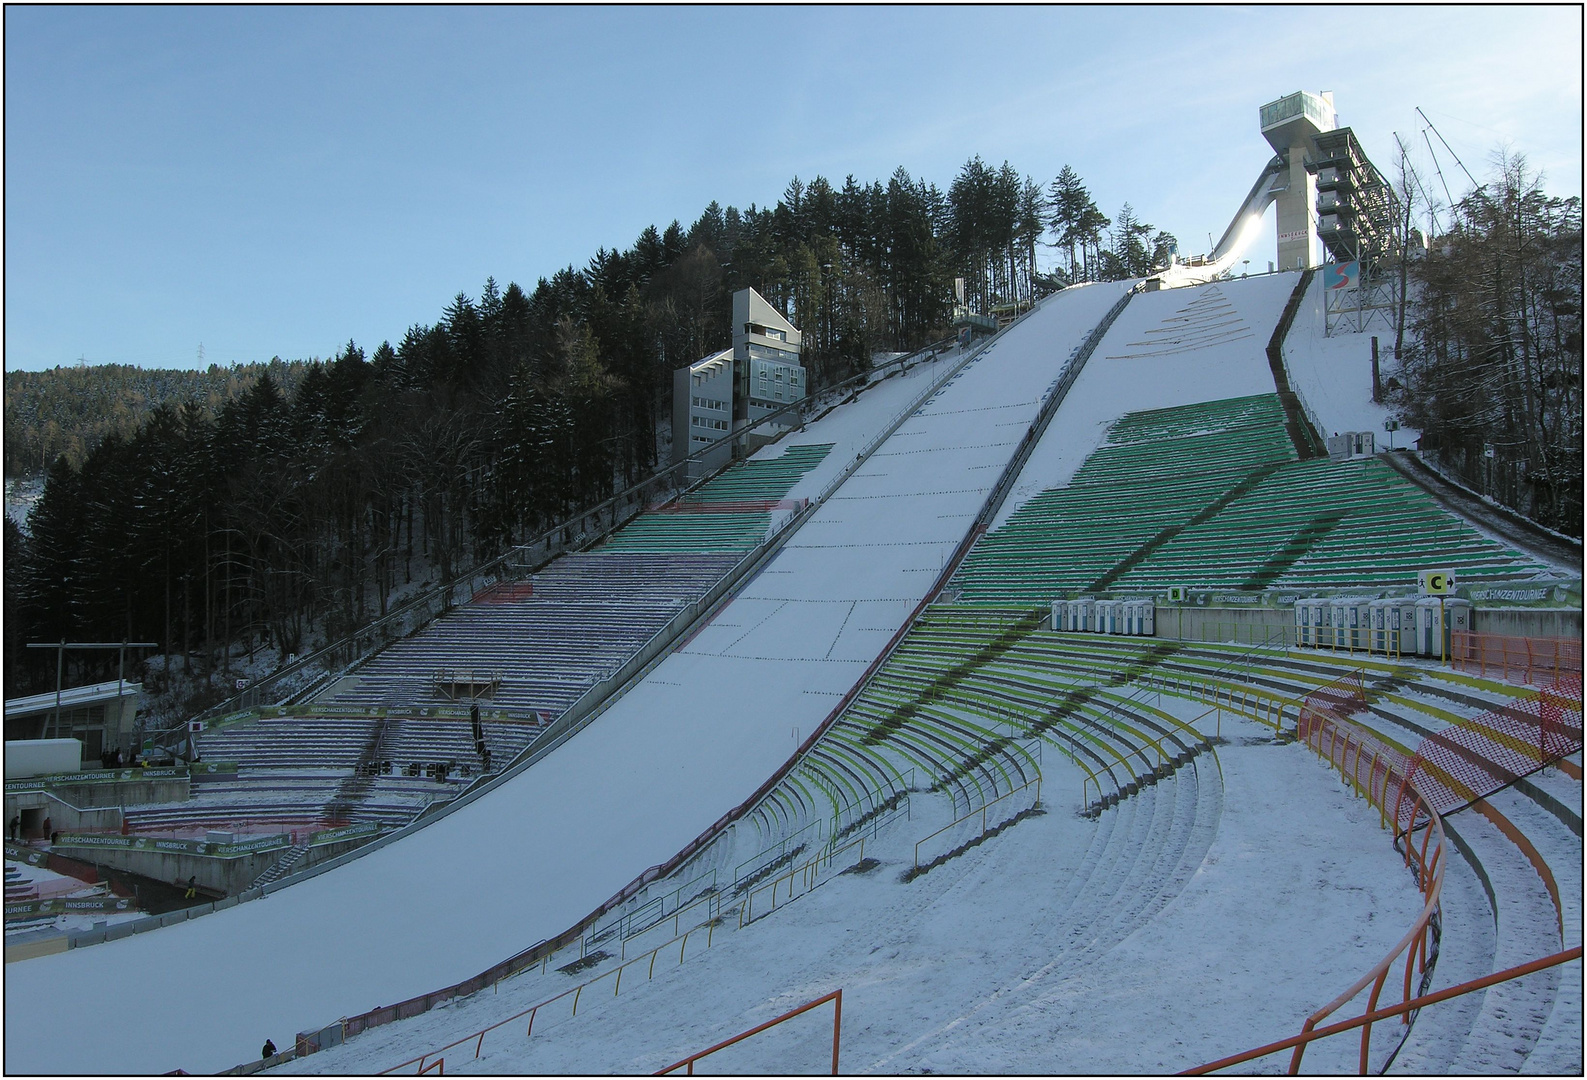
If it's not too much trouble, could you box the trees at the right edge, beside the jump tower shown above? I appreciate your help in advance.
[1401,155,1582,536]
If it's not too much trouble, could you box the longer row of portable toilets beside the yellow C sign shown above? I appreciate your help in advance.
[1295,596,1471,657]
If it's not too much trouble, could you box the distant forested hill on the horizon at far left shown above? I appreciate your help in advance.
[5,357,308,477]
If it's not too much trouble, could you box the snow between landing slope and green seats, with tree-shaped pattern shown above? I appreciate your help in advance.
[992,273,1298,528]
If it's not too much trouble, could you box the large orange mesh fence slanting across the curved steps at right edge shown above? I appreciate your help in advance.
[1409,676,1582,814]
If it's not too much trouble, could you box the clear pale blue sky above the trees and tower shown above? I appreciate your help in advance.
[5,5,1582,368]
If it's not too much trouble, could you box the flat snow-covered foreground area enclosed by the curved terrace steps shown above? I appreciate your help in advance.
[282,717,1420,1075]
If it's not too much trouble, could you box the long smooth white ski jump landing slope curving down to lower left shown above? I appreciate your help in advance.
[5,284,1125,1074]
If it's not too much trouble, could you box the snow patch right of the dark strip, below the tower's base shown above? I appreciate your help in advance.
[1284,273,1420,449]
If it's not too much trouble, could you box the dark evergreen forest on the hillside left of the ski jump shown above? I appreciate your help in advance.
[5,159,1171,696]
